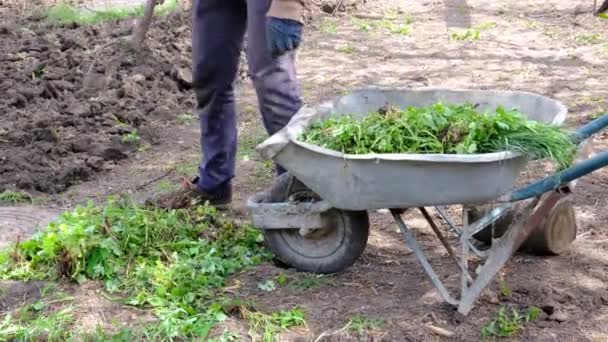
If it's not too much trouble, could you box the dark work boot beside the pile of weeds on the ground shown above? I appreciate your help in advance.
[145,177,232,209]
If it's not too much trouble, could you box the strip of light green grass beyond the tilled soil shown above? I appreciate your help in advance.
[47,0,180,25]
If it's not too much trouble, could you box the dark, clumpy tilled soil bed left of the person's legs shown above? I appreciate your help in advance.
[0,12,193,193]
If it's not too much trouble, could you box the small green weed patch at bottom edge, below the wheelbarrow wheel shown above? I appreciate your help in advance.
[242,308,306,342]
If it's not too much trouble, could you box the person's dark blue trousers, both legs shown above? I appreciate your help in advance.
[192,0,302,192]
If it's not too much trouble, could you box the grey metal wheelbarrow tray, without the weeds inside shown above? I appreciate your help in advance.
[258,88,567,210]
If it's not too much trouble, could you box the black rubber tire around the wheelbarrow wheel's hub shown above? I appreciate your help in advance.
[265,209,369,274]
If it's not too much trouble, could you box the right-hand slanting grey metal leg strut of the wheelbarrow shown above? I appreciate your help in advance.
[458,191,568,316]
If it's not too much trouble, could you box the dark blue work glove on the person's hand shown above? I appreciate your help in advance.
[266,17,302,57]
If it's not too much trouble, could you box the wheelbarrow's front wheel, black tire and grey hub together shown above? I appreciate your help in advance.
[265,209,369,274]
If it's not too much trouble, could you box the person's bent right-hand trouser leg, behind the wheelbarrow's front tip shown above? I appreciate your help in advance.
[247,0,302,174]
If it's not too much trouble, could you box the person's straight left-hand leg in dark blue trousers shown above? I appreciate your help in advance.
[192,0,247,193]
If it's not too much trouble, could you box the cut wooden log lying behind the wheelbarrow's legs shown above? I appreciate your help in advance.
[468,198,578,255]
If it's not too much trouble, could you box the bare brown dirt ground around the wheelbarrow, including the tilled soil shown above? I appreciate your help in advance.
[0,0,608,341]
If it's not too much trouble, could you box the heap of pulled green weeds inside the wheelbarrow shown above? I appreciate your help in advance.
[299,103,576,168]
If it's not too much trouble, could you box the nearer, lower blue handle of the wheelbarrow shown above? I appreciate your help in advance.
[497,151,608,203]
